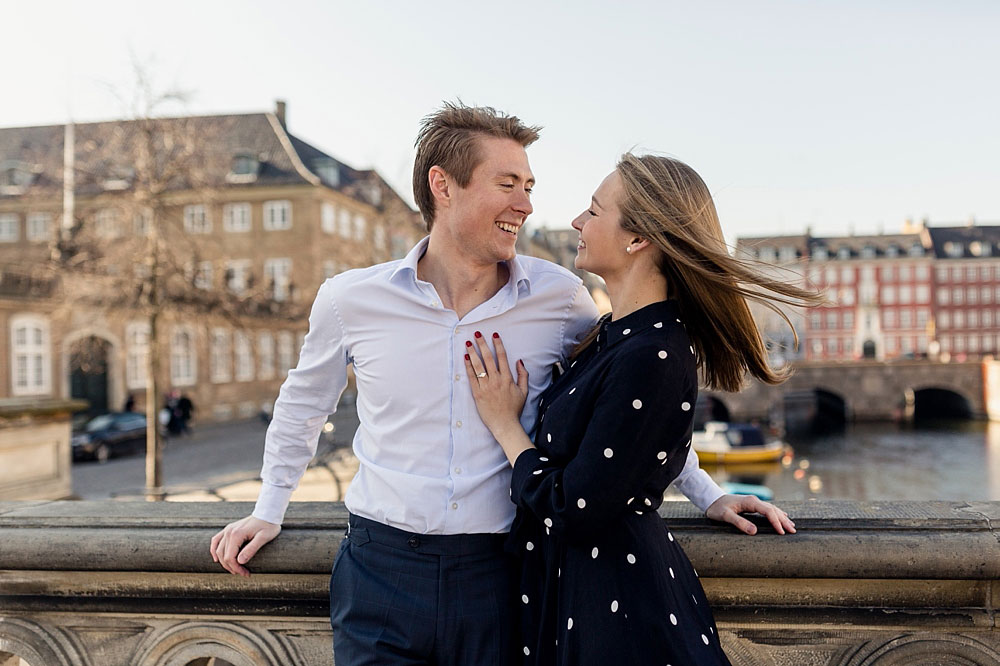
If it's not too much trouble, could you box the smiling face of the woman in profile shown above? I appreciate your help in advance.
[573,170,632,281]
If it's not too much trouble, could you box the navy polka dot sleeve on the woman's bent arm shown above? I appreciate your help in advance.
[511,344,697,541]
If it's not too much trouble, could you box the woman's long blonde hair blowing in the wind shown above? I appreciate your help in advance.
[584,153,823,391]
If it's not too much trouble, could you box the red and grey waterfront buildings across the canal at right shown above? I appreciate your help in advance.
[737,221,1000,361]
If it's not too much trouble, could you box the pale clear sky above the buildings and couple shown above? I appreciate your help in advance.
[0,0,1000,241]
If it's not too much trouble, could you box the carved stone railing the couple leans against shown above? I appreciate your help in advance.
[0,502,1000,666]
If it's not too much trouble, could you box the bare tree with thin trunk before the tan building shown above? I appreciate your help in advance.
[50,64,301,500]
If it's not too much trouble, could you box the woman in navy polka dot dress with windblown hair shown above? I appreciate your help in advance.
[466,154,818,666]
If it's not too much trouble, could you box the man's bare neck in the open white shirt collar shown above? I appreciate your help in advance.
[417,236,510,319]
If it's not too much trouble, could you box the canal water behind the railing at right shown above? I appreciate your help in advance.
[705,421,1000,502]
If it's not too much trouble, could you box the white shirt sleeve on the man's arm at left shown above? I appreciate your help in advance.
[253,280,348,524]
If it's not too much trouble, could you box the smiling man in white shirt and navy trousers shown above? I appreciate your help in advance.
[211,104,777,666]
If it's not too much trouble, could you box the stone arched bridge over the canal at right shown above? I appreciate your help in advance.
[703,359,1000,421]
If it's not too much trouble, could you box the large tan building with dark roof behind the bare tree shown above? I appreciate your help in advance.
[0,102,425,421]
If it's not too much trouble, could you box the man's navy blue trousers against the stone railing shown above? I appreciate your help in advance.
[330,515,516,666]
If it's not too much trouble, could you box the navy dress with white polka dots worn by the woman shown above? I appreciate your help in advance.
[507,301,729,666]
